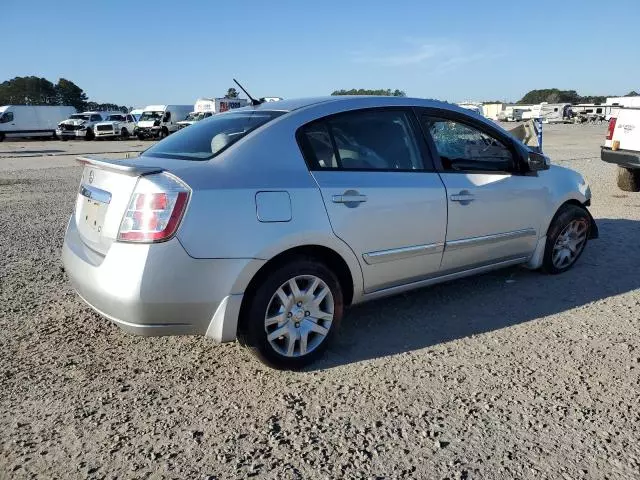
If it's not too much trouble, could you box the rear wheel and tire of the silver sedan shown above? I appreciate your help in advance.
[238,257,344,370]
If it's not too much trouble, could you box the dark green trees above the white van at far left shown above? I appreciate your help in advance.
[0,76,130,112]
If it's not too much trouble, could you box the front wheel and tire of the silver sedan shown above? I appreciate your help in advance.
[542,205,591,275]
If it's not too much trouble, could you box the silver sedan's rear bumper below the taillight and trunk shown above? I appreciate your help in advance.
[62,218,263,342]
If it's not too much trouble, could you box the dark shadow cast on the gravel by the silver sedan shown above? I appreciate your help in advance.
[311,218,640,370]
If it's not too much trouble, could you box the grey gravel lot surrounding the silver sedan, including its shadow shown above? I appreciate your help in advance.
[0,126,640,479]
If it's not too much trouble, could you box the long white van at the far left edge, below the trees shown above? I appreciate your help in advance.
[0,105,76,142]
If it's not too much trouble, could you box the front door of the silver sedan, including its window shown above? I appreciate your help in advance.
[421,110,549,273]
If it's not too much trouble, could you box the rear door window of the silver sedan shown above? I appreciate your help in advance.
[301,110,423,171]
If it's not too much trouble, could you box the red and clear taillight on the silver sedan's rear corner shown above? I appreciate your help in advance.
[118,173,191,243]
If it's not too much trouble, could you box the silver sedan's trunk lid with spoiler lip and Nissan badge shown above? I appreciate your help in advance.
[73,157,163,255]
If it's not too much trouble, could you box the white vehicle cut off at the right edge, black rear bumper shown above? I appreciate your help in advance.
[600,108,640,192]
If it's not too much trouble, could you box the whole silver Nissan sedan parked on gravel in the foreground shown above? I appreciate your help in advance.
[62,97,598,368]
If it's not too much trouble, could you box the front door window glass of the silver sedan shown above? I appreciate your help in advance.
[422,117,513,172]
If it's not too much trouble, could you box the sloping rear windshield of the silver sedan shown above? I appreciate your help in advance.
[142,110,285,160]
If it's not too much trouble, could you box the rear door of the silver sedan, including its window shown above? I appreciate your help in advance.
[298,109,447,293]
